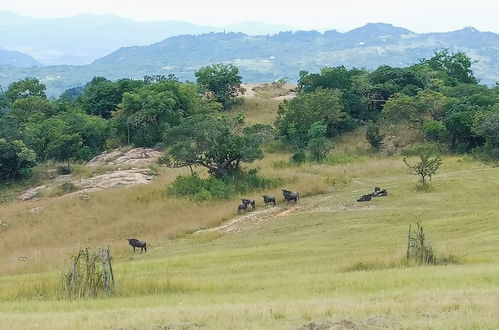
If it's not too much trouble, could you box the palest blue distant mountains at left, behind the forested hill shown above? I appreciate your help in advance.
[0,11,292,65]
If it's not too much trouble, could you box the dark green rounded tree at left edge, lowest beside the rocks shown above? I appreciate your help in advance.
[0,139,36,181]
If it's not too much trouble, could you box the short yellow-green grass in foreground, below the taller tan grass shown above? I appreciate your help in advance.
[0,158,499,329]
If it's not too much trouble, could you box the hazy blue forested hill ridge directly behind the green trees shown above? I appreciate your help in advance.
[0,23,499,94]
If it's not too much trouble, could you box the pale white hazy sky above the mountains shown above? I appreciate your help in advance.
[0,0,499,33]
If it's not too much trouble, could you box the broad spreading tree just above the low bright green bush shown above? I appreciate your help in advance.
[164,115,268,177]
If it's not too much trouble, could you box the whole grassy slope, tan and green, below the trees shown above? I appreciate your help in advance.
[0,89,499,330]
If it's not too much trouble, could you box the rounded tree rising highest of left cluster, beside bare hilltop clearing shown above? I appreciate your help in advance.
[195,63,245,109]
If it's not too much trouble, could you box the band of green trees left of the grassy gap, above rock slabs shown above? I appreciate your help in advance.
[0,65,261,181]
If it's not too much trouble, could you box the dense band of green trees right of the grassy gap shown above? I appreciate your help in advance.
[276,50,499,158]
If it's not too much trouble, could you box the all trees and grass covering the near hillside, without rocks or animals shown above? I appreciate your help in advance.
[0,51,499,330]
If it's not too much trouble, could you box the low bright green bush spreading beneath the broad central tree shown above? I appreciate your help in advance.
[167,171,280,201]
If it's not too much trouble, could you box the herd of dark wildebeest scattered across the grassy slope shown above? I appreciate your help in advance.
[127,187,388,253]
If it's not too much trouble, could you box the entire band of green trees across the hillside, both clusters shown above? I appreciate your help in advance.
[0,50,499,181]
